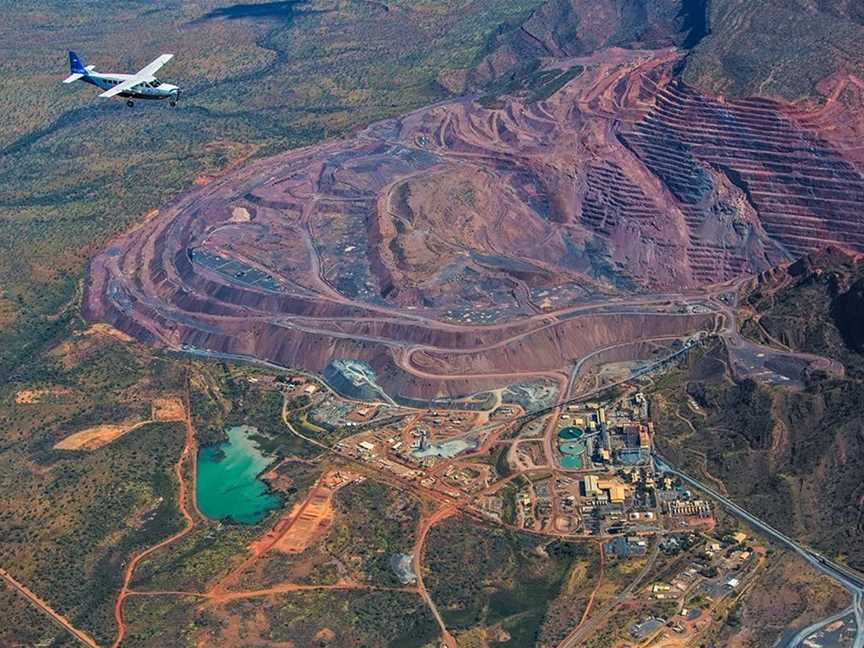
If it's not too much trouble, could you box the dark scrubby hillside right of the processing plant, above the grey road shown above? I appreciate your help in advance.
[655,249,864,569]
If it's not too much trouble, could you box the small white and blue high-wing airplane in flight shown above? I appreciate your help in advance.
[63,52,180,108]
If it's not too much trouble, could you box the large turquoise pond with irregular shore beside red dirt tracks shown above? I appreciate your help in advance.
[195,425,282,524]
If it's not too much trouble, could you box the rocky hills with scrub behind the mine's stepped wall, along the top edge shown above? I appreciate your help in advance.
[439,0,864,101]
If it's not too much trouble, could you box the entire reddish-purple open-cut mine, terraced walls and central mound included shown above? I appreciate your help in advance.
[86,50,864,397]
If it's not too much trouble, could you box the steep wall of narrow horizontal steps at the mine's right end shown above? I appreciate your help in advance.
[619,81,864,264]
